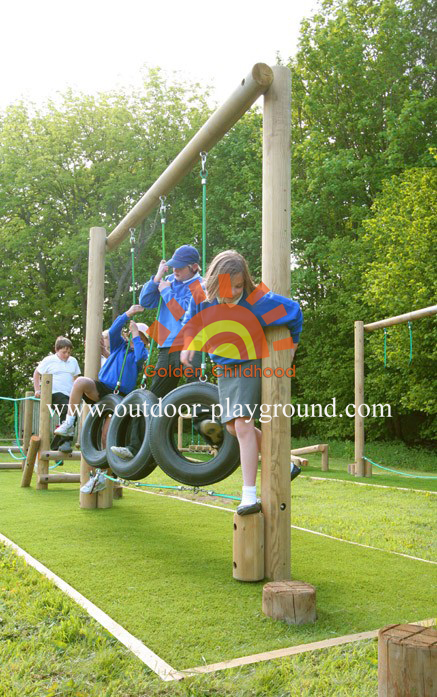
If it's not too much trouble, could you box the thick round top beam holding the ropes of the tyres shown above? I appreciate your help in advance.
[106,63,273,250]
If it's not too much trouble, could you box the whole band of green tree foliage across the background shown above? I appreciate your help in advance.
[0,0,436,440]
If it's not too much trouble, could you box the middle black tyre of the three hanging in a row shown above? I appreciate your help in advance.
[106,390,158,480]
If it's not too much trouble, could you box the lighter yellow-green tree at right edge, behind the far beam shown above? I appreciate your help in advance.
[364,161,437,439]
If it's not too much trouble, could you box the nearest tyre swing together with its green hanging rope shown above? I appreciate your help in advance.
[150,153,240,486]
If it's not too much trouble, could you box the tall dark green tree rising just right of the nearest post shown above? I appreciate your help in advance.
[290,0,436,436]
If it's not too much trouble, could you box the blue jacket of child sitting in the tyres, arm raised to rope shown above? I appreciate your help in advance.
[99,312,149,394]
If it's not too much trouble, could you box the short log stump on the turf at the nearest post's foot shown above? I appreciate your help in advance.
[262,581,317,624]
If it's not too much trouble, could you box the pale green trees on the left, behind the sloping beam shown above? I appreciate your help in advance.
[0,70,209,402]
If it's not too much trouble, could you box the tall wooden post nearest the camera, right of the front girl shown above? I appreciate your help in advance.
[261,66,291,581]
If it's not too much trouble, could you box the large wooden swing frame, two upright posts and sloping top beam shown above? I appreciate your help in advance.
[77,63,291,580]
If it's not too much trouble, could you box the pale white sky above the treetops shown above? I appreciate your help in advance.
[0,0,317,109]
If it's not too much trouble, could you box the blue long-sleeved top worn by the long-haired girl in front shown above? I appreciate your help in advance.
[177,291,303,365]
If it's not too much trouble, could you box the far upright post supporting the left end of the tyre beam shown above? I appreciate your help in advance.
[80,227,107,508]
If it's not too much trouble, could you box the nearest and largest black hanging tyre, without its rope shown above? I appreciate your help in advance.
[151,382,240,486]
